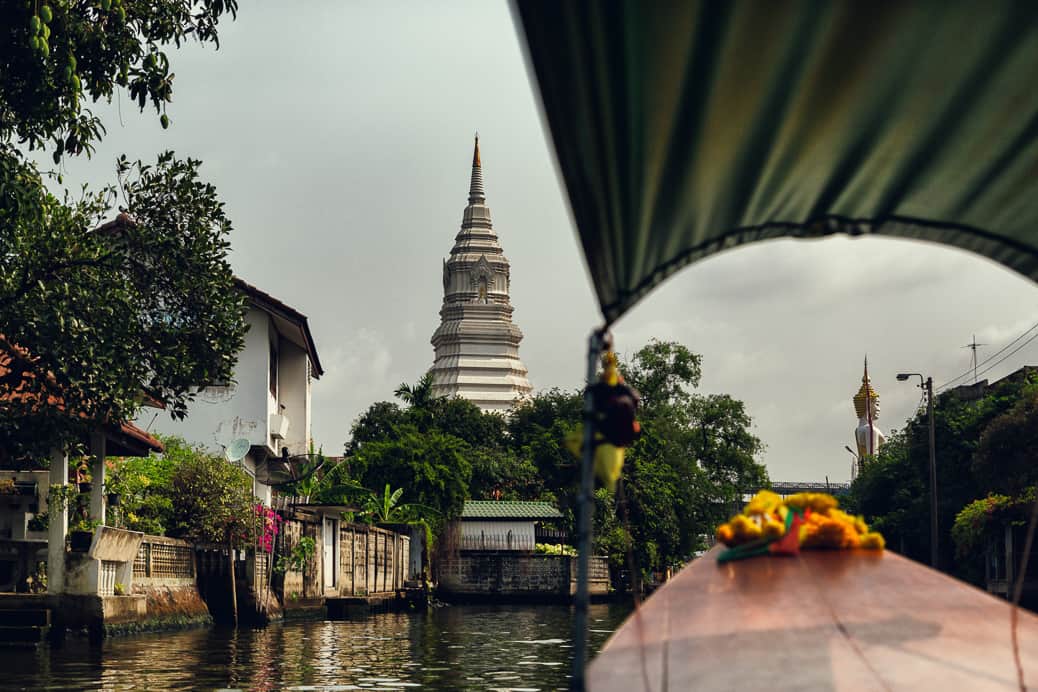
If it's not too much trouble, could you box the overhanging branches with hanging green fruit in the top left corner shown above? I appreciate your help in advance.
[0,0,238,154]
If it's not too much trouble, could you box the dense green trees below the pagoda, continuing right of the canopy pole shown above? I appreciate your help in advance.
[347,341,767,571]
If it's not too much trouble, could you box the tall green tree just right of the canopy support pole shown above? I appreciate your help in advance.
[596,340,768,571]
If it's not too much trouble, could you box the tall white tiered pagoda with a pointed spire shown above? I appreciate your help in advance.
[432,135,532,412]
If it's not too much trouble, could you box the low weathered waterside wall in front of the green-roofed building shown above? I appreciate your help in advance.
[438,552,609,601]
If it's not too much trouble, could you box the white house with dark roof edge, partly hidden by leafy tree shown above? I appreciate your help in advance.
[137,279,324,504]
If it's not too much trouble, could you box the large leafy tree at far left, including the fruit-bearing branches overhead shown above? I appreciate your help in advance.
[0,0,246,456]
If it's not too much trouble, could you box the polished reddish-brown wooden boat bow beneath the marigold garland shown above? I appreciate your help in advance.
[588,549,1038,692]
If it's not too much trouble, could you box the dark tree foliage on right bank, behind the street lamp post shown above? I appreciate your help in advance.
[849,371,1038,583]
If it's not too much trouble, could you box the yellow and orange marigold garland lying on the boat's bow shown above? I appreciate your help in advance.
[716,490,884,562]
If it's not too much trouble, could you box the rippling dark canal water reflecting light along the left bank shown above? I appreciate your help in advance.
[0,604,630,691]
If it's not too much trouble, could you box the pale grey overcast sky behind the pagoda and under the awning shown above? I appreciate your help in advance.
[52,0,1038,480]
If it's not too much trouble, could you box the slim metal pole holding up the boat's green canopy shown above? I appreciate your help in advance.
[570,329,605,692]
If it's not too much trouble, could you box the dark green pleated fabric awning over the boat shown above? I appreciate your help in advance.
[514,0,1038,322]
